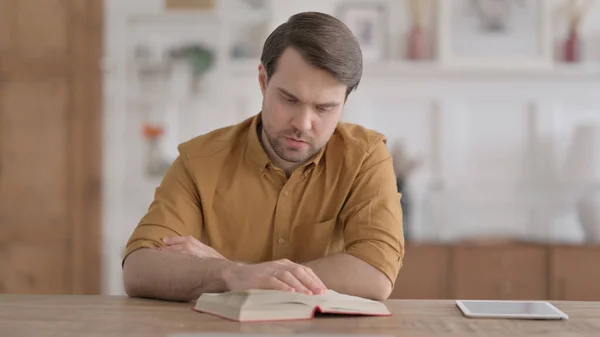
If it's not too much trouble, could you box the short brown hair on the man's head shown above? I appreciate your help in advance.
[260,12,363,97]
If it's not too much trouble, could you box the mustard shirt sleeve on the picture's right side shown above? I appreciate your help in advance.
[340,139,404,286]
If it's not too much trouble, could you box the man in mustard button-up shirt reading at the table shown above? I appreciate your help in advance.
[123,12,404,301]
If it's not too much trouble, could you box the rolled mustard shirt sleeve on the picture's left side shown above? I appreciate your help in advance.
[123,156,203,262]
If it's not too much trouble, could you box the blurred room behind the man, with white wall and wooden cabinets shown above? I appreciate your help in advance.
[0,0,600,300]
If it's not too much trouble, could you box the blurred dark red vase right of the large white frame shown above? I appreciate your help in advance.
[562,0,594,63]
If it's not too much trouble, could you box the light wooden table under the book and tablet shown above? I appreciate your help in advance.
[0,295,600,337]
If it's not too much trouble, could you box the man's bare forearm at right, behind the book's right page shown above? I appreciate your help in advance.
[304,253,392,300]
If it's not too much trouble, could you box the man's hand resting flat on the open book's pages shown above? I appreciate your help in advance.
[223,259,327,295]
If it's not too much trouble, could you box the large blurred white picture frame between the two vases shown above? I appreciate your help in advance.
[438,0,553,69]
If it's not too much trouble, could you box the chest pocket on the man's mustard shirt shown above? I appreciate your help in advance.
[293,217,344,263]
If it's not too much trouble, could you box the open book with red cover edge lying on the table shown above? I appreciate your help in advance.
[194,290,391,322]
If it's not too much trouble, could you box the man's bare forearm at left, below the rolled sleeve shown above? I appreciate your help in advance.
[123,249,236,301]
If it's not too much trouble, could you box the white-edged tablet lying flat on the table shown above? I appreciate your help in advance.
[462,301,561,317]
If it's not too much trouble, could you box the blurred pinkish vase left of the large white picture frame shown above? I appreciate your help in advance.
[406,0,431,60]
